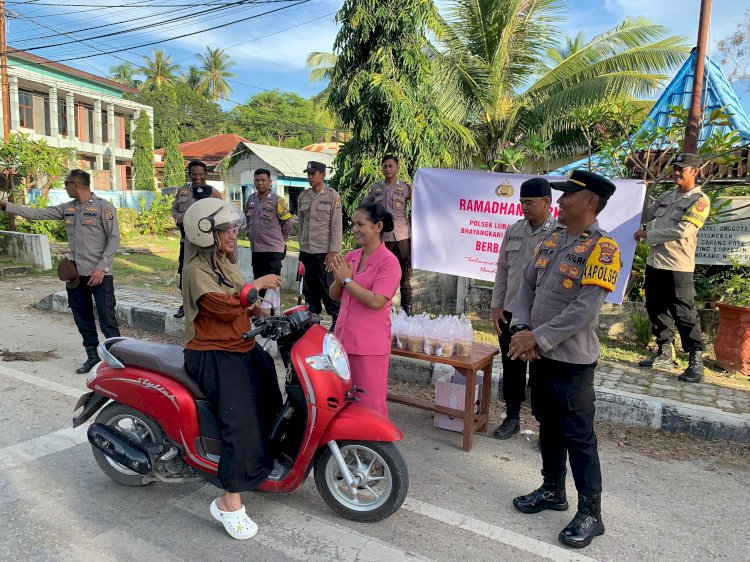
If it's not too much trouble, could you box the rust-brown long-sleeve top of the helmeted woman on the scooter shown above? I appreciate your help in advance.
[185,293,255,353]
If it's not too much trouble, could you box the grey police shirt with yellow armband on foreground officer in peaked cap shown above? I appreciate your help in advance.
[511,221,621,365]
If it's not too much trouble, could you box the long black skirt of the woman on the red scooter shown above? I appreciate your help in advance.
[185,346,281,492]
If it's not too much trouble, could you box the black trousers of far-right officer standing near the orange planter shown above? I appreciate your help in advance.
[644,265,705,352]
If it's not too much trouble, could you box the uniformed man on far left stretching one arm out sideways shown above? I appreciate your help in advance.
[0,169,120,374]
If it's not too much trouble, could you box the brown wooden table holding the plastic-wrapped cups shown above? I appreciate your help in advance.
[388,343,499,451]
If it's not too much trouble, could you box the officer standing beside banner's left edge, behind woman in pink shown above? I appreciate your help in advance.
[361,154,412,314]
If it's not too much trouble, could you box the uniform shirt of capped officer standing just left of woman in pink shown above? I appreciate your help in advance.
[297,186,342,254]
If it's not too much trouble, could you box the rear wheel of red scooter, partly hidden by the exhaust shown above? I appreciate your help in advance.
[91,402,164,487]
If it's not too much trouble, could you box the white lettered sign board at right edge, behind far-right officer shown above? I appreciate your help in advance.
[695,197,750,265]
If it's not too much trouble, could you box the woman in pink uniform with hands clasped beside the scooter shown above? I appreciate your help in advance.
[329,203,401,416]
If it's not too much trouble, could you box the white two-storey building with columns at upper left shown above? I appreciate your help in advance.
[0,49,153,191]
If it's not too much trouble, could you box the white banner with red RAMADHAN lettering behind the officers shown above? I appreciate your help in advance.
[412,168,646,303]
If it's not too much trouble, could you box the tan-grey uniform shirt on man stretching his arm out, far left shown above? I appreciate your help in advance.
[5,194,120,275]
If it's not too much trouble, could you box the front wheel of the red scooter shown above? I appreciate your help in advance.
[315,441,409,523]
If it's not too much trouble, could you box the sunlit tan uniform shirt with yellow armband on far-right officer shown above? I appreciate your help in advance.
[641,187,711,272]
